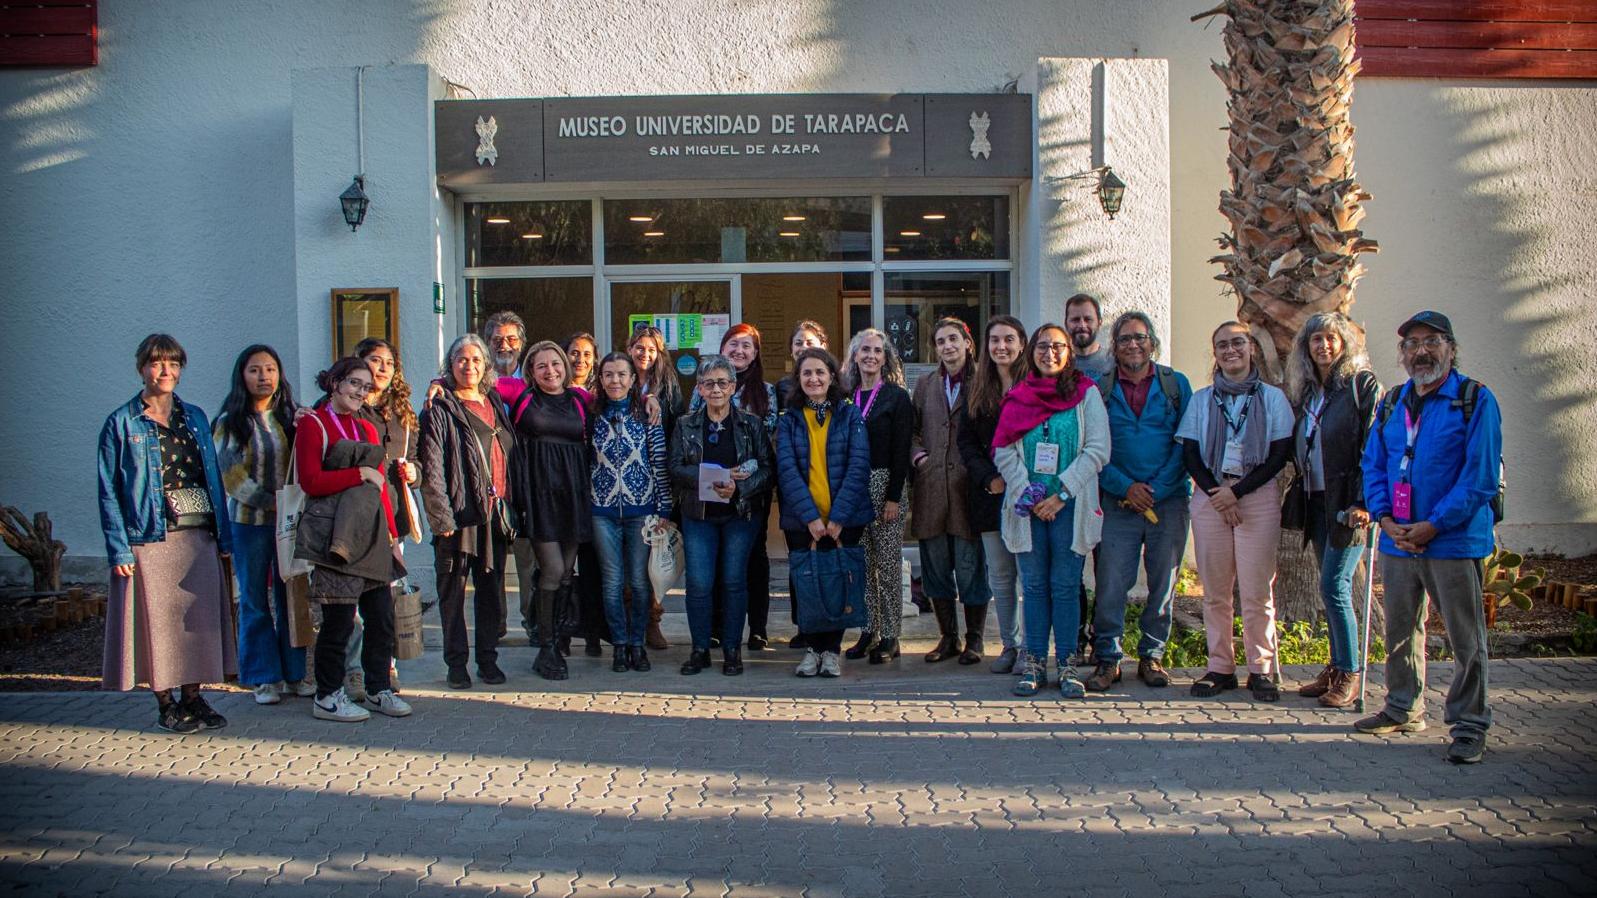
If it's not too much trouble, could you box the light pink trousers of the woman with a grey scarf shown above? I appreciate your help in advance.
[1191,481,1281,674]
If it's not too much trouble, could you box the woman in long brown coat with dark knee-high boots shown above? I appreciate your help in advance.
[910,318,992,665]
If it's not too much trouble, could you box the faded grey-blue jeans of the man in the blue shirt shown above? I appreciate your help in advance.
[1092,494,1188,663]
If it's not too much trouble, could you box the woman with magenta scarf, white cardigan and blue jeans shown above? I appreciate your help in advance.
[993,324,1108,698]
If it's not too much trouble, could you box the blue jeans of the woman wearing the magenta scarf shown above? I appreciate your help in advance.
[1016,499,1086,666]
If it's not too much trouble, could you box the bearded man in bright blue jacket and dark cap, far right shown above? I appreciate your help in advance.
[1354,312,1503,764]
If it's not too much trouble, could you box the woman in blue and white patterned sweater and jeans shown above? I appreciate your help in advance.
[589,352,671,673]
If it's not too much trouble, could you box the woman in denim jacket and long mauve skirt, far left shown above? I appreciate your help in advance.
[99,334,238,733]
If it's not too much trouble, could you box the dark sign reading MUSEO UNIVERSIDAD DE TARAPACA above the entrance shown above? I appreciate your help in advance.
[436,94,1033,190]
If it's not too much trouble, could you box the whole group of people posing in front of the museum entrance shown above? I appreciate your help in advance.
[99,294,1501,762]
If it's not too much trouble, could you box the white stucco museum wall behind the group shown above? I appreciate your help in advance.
[0,0,1597,567]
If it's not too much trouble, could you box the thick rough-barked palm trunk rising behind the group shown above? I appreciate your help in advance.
[1193,0,1378,361]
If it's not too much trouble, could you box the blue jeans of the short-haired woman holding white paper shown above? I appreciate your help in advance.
[682,518,765,652]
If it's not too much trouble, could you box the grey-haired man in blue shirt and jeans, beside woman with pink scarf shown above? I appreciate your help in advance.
[1086,312,1193,692]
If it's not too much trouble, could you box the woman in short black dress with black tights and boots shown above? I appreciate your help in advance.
[511,340,592,679]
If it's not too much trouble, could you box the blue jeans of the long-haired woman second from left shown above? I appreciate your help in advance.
[233,523,305,685]
